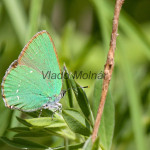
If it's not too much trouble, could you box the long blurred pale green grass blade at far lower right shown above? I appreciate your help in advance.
[119,40,146,150]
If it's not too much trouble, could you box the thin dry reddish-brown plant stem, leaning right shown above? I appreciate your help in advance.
[92,0,124,142]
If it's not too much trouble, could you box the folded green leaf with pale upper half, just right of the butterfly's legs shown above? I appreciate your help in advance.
[62,109,91,136]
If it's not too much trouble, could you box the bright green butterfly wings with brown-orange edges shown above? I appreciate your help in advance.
[2,31,62,111]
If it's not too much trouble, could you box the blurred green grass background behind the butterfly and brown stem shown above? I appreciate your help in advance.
[0,0,150,150]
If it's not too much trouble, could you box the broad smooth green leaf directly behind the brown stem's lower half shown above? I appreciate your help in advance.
[93,80,115,150]
